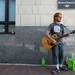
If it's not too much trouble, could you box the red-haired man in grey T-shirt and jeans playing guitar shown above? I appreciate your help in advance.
[46,12,67,72]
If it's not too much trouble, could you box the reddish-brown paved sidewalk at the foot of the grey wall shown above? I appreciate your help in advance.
[0,64,75,75]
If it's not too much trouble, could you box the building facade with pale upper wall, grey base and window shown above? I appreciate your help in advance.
[0,0,75,64]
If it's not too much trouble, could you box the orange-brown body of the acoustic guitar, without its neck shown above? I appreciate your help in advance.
[42,34,57,50]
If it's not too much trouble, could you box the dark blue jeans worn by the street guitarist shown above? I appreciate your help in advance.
[52,43,64,65]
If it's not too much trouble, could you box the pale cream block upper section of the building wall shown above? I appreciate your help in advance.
[16,0,75,26]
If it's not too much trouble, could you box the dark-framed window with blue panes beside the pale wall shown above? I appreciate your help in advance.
[0,0,16,34]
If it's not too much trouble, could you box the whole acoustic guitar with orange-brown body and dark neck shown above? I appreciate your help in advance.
[42,30,75,50]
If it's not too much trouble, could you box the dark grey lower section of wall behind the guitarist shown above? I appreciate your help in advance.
[0,26,75,64]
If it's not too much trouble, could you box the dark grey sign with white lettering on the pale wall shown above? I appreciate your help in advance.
[57,0,75,9]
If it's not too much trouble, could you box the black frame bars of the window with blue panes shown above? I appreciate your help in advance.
[0,0,15,34]
